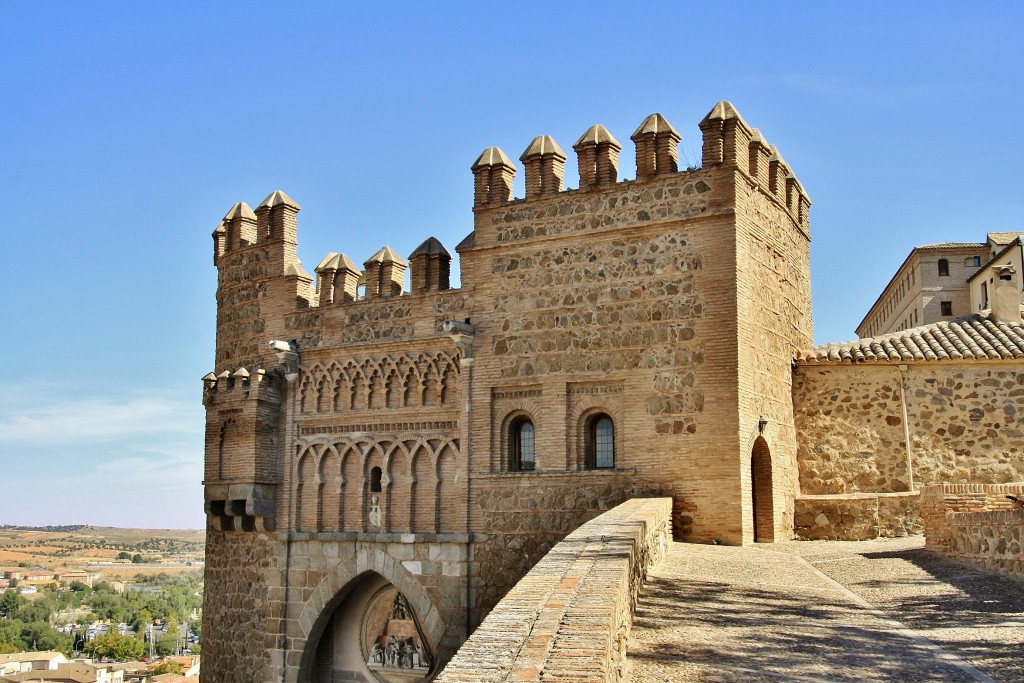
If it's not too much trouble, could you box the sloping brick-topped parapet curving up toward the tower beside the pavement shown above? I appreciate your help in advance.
[436,498,672,683]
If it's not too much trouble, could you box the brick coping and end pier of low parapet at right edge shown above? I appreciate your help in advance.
[921,482,1024,552]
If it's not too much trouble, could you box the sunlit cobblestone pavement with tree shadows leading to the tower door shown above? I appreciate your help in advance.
[627,537,1024,683]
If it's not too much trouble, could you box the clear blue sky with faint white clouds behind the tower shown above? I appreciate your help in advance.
[0,0,1024,527]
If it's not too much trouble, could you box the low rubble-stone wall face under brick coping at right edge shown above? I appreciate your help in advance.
[945,509,1024,579]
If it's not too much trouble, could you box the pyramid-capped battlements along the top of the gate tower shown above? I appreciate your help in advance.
[213,100,810,337]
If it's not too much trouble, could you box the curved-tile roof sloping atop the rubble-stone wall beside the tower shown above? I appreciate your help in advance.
[797,315,1024,364]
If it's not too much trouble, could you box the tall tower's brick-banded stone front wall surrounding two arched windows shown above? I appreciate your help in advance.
[460,169,742,543]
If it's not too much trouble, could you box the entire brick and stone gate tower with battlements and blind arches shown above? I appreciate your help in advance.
[204,102,811,683]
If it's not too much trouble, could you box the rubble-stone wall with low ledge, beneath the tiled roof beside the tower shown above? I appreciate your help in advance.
[794,361,1024,538]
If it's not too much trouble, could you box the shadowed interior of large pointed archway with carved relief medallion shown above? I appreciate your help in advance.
[309,572,433,683]
